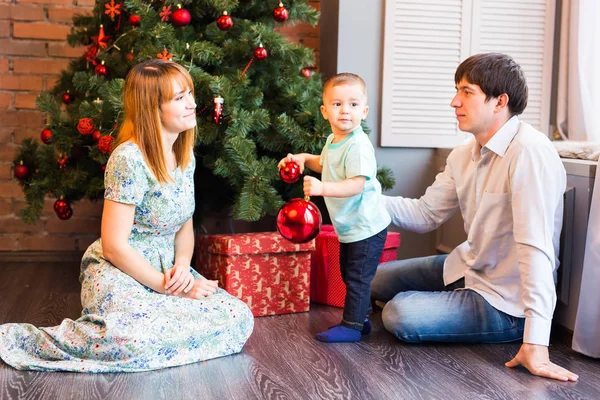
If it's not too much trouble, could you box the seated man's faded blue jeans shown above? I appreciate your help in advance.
[371,255,525,343]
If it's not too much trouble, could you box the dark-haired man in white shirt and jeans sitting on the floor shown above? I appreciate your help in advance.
[371,53,578,381]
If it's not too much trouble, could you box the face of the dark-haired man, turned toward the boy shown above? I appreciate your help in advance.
[450,78,497,136]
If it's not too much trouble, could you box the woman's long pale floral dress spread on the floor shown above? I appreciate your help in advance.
[0,143,254,372]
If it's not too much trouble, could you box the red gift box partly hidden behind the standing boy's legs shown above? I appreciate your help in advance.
[310,225,400,308]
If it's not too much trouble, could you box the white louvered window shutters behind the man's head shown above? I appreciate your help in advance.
[381,0,554,148]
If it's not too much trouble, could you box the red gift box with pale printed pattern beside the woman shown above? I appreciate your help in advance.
[196,232,315,317]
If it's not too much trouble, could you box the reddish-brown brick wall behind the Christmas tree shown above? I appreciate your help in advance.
[0,0,320,251]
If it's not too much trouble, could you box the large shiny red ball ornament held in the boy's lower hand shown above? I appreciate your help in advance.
[277,198,321,243]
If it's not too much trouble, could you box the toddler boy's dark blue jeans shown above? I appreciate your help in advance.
[340,229,387,331]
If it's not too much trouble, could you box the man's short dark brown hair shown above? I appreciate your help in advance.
[454,53,528,115]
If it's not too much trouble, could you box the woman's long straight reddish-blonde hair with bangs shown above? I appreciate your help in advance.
[113,59,196,183]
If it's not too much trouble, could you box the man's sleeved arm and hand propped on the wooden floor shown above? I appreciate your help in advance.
[505,145,578,381]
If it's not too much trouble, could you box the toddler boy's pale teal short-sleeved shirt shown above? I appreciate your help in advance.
[319,127,391,243]
